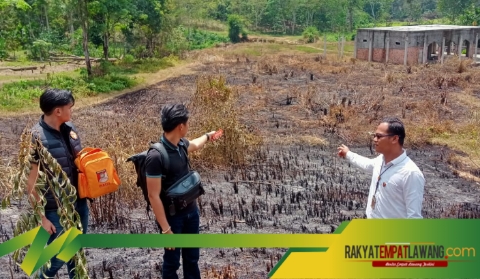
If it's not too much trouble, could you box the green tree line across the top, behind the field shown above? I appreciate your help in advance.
[0,0,480,74]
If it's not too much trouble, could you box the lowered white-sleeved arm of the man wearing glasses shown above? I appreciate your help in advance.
[403,171,425,219]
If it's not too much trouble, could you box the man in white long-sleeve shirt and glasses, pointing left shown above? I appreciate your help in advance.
[338,118,425,219]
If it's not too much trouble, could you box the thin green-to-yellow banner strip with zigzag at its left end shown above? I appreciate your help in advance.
[0,227,338,276]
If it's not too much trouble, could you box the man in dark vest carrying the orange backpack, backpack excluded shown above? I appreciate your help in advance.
[27,89,89,278]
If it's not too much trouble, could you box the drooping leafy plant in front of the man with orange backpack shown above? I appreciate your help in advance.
[2,130,89,278]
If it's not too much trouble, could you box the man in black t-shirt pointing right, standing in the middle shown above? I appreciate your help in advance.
[145,104,222,279]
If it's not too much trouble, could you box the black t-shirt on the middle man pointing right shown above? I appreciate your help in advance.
[145,136,196,215]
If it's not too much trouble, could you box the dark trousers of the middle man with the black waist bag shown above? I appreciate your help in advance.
[162,207,201,279]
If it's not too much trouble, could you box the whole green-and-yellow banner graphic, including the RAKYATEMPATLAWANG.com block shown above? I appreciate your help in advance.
[0,219,480,278]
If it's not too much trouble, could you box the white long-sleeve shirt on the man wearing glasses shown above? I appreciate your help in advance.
[346,150,425,219]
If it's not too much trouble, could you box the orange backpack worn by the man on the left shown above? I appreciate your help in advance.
[75,147,121,199]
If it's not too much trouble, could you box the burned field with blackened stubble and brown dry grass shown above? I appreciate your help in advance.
[0,45,480,278]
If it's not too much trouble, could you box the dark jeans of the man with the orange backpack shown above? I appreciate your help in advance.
[39,199,89,279]
